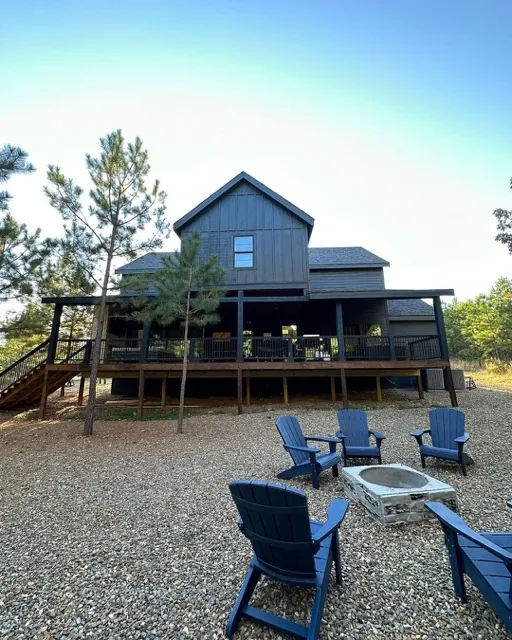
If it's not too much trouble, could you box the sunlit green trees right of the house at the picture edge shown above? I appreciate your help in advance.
[444,278,512,362]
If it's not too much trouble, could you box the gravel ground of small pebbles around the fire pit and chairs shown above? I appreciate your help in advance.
[0,390,512,640]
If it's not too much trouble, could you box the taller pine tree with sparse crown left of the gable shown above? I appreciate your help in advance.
[45,129,170,435]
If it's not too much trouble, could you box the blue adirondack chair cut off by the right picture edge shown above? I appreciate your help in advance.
[425,502,512,631]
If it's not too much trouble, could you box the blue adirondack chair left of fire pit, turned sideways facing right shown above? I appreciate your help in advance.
[276,416,341,489]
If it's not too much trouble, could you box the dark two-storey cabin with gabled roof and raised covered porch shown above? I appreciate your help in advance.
[0,172,457,414]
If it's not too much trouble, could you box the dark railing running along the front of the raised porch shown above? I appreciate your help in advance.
[46,335,441,364]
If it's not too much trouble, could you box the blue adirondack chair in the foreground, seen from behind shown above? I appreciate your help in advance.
[226,480,348,640]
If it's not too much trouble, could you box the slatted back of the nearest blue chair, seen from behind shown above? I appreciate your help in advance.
[229,480,318,579]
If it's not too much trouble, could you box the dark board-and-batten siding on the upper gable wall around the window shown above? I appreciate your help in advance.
[181,183,309,288]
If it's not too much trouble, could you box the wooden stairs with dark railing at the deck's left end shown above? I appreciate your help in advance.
[0,339,84,409]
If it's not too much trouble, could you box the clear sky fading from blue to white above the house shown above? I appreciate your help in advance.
[0,0,512,299]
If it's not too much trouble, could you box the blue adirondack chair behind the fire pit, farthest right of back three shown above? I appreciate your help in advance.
[411,409,469,476]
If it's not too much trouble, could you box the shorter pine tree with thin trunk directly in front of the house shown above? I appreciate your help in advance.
[124,233,224,433]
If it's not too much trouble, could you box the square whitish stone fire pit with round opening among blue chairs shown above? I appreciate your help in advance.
[342,464,457,525]
